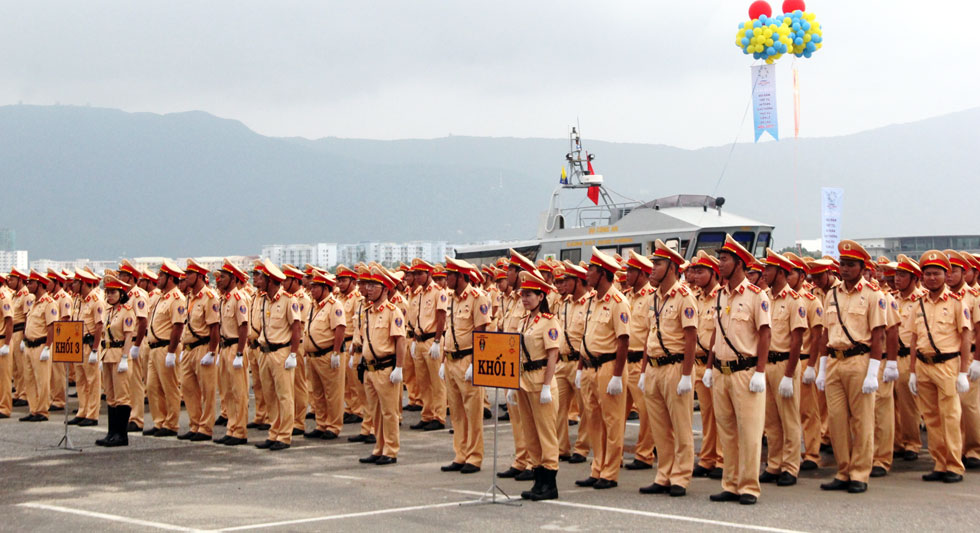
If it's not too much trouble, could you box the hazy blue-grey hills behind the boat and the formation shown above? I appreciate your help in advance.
[0,106,980,259]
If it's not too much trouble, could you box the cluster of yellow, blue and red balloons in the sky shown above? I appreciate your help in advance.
[735,0,823,64]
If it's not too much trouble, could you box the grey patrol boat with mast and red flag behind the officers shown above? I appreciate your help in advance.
[455,127,773,265]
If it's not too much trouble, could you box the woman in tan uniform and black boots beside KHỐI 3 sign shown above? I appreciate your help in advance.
[95,276,137,448]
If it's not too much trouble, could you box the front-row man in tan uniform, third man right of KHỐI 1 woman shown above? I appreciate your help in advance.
[702,235,771,505]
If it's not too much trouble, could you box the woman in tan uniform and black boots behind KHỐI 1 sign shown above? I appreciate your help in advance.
[508,270,562,501]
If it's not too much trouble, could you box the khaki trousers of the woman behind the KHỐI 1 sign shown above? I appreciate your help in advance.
[512,369,568,470]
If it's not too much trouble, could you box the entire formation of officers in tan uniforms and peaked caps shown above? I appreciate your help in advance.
[0,236,980,505]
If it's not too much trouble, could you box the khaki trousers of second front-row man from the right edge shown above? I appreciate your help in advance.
[824,355,875,483]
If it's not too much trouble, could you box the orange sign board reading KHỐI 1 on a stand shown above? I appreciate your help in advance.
[473,331,521,390]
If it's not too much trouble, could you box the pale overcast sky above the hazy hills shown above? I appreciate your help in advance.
[0,0,980,148]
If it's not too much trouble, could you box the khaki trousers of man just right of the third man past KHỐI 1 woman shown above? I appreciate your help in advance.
[765,361,803,476]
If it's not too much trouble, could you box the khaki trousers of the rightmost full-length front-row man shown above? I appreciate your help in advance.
[915,357,964,474]
